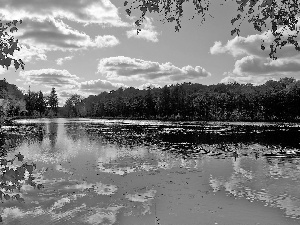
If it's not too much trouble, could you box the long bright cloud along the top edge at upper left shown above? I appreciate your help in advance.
[0,0,128,27]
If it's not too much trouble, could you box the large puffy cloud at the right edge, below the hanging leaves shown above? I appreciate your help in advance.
[210,29,300,84]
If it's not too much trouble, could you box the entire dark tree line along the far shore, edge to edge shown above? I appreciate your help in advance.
[0,77,300,122]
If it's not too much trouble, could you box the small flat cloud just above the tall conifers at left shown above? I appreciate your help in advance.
[20,69,79,88]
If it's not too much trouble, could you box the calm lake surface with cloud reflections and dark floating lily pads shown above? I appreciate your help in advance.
[0,119,300,225]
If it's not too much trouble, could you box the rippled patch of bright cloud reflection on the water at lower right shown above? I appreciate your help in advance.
[209,158,300,218]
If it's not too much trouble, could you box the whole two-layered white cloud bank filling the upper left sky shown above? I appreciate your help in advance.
[0,0,123,62]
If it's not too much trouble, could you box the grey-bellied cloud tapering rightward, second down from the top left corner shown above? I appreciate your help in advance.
[16,18,119,52]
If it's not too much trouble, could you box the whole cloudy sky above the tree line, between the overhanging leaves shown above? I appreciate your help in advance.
[0,0,300,101]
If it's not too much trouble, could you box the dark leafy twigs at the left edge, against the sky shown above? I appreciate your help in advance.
[0,20,25,70]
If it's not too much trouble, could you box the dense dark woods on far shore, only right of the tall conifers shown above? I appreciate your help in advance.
[79,78,300,121]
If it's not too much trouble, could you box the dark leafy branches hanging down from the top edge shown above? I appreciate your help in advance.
[124,0,300,59]
